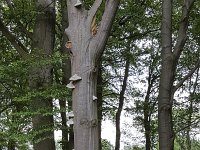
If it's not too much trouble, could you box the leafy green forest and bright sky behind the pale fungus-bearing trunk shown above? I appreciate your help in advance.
[0,0,200,150]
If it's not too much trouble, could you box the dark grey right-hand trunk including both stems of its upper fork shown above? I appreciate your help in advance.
[158,0,194,150]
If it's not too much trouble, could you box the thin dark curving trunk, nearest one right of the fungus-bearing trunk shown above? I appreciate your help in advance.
[115,58,130,150]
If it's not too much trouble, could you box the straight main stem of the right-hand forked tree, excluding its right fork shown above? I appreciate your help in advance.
[158,0,174,150]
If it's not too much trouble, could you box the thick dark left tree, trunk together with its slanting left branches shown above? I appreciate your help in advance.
[0,0,55,150]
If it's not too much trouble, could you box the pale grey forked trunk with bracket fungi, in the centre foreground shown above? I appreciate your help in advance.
[65,0,119,150]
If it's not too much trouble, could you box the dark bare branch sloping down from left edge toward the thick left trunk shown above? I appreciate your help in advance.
[0,18,28,57]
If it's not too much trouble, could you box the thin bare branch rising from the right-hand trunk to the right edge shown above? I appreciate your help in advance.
[173,59,200,93]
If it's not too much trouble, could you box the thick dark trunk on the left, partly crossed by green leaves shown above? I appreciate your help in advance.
[30,0,55,150]
